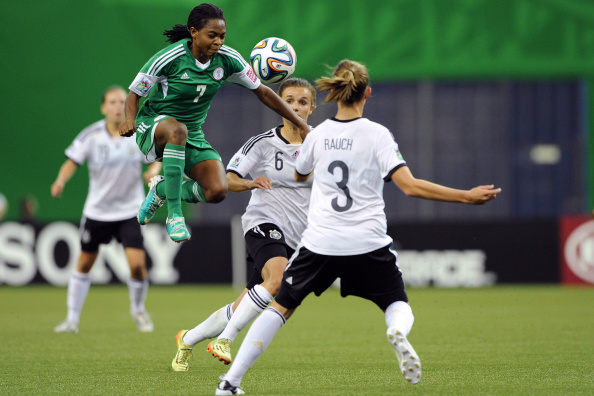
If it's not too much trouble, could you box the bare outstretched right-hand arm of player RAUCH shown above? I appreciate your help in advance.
[392,166,501,205]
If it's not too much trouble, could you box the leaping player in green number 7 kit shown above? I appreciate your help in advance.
[120,3,309,242]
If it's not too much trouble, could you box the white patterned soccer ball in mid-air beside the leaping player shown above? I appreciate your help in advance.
[250,37,297,84]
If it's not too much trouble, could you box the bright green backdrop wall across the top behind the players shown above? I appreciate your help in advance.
[0,0,594,221]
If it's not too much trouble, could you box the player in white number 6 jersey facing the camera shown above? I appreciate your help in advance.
[171,78,316,371]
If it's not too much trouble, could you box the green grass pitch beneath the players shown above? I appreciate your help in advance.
[0,286,594,396]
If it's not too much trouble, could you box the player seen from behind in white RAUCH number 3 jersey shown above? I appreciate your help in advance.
[216,60,501,395]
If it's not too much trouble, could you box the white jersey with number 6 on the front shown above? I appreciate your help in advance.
[227,127,312,249]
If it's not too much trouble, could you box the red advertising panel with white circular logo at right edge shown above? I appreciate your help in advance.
[559,216,594,285]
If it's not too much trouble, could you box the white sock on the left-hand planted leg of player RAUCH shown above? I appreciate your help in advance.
[224,307,286,386]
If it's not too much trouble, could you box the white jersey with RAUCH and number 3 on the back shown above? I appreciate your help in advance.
[296,118,406,256]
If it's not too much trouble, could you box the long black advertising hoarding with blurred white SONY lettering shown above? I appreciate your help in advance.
[0,220,560,287]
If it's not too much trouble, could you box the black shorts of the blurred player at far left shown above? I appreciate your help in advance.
[80,217,144,253]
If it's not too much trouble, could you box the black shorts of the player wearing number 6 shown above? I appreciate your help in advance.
[245,223,294,289]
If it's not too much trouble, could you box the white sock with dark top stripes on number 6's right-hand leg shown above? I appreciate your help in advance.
[218,285,272,341]
